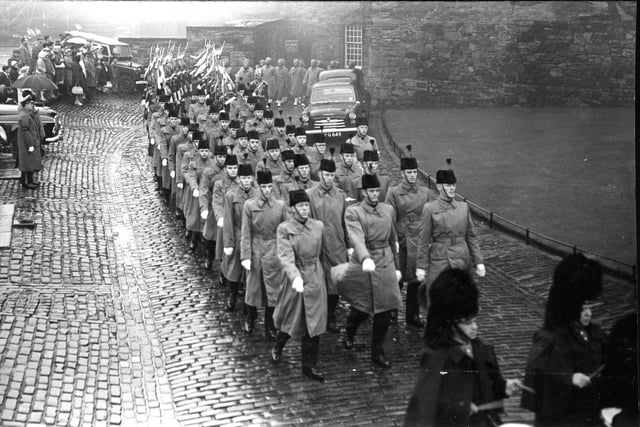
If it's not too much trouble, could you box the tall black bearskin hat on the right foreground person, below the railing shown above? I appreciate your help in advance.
[544,254,602,329]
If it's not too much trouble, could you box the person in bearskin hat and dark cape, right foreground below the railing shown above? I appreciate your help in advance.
[520,254,607,427]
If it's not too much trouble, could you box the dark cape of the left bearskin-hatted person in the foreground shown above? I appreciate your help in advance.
[404,339,507,427]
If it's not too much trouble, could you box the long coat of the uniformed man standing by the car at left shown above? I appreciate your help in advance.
[17,108,45,172]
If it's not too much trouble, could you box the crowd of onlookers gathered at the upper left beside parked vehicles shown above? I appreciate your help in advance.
[0,34,115,105]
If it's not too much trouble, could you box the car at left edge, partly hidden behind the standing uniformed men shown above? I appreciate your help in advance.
[0,104,62,151]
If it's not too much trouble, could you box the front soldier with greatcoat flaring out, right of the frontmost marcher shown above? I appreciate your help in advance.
[332,175,402,368]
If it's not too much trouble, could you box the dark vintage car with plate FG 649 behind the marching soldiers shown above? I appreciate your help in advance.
[300,69,371,141]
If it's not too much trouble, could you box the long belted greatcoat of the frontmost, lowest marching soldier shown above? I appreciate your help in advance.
[273,218,327,337]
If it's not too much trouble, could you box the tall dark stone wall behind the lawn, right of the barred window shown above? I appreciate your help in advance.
[364,2,636,106]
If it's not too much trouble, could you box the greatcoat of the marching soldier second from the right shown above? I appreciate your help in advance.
[385,178,434,282]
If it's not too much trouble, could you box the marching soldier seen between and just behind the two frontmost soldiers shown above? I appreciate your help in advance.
[307,154,349,333]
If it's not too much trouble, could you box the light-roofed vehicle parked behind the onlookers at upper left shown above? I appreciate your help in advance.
[65,31,147,93]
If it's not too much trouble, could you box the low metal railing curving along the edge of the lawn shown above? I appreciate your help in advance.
[380,109,636,283]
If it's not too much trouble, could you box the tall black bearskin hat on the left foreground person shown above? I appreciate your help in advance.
[421,268,479,348]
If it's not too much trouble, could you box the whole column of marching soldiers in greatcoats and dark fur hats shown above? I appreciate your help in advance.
[146,87,484,381]
